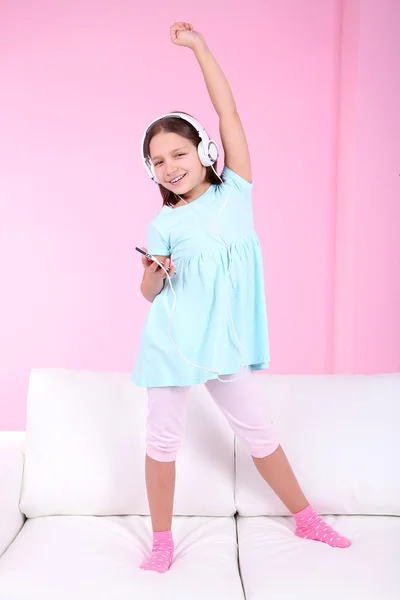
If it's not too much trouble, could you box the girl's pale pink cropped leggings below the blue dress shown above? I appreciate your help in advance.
[146,367,279,462]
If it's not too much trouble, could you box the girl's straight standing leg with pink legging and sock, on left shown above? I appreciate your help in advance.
[141,386,190,573]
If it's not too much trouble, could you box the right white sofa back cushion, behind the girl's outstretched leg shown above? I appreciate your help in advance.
[235,373,400,516]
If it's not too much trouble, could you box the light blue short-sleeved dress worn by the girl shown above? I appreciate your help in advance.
[131,167,270,387]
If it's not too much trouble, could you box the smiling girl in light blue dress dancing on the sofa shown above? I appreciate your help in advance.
[132,22,351,573]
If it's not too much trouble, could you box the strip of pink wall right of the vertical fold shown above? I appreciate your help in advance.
[333,0,400,372]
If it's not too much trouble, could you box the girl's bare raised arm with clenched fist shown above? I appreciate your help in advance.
[170,22,252,183]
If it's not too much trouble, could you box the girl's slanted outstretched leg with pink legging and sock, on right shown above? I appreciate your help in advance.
[206,367,350,548]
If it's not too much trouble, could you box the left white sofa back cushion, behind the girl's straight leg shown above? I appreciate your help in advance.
[20,369,236,518]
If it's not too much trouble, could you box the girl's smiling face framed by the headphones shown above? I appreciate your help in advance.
[150,132,206,195]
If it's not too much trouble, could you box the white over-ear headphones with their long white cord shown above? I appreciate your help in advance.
[141,113,250,383]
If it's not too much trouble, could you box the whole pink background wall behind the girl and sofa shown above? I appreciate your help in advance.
[0,0,400,430]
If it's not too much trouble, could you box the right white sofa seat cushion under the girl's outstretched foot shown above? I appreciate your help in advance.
[238,515,400,600]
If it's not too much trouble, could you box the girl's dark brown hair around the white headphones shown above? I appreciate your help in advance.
[143,111,221,206]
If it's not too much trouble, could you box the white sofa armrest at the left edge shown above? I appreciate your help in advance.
[0,431,26,557]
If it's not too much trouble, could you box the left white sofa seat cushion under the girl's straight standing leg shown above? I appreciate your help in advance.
[0,515,244,600]
